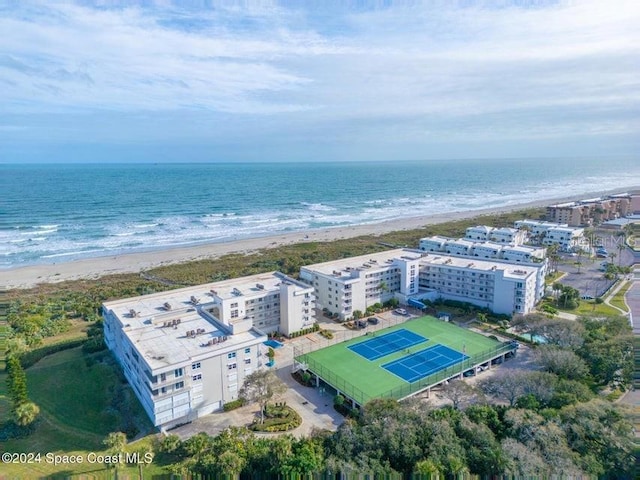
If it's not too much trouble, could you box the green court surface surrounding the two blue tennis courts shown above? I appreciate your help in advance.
[296,317,509,403]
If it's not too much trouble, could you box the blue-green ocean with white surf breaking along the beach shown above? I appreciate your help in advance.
[0,157,640,269]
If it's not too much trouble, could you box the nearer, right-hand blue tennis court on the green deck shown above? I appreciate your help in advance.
[382,344,469,383]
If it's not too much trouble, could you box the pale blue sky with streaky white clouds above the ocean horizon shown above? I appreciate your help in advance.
[0,0,640,163]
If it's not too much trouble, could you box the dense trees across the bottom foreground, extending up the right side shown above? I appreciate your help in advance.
[146,315,634,479]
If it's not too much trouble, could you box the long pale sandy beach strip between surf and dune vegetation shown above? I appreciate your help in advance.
[0,187,636,290]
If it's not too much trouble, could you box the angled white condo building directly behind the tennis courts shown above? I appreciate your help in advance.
[300,248,546,319]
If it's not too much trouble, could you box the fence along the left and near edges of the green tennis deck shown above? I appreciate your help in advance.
[294,342,517,405]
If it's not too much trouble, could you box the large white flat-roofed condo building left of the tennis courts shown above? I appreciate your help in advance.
[102,272,314,430]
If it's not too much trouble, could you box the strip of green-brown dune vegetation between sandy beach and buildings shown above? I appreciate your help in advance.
[7,208,544,301]
